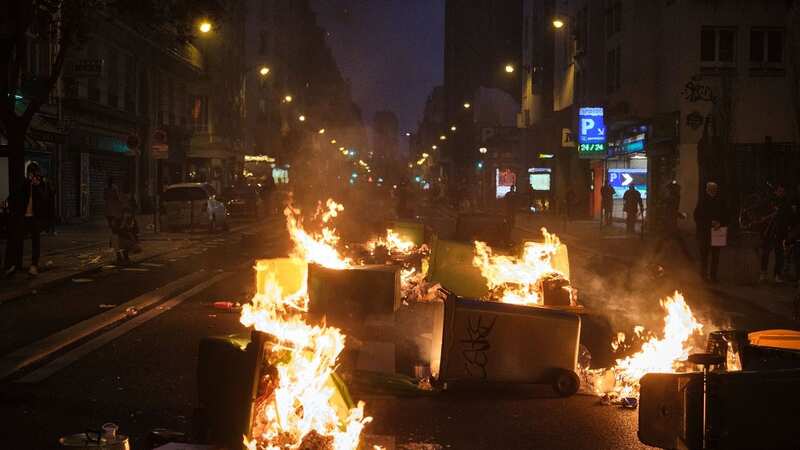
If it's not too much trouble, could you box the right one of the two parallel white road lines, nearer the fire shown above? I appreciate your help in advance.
[16,272,234,383]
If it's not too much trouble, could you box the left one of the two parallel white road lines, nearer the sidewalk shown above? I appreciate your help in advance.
[0,270,208,380]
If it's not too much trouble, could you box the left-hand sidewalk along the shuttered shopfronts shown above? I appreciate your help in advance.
[0,215,252,304]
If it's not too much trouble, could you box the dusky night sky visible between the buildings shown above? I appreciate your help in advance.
[311,0,444,135]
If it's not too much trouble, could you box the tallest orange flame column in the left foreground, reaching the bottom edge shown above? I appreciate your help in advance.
[239,267,372,450]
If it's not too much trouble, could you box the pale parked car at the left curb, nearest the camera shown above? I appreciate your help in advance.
[161,183,228,232]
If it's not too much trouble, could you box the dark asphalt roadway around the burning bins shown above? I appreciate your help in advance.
[0,215,782,450]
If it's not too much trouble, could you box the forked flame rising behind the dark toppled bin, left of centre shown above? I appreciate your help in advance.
[283,199,352,270]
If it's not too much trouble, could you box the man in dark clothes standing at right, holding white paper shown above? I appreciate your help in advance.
[694,181,728,282]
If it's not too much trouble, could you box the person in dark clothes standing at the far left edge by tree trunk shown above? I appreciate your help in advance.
[5,162,47,277]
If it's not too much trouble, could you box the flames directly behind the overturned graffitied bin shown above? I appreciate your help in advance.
[472,228,565,305]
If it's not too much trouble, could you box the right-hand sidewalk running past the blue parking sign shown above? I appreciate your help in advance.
[516,214,797,317]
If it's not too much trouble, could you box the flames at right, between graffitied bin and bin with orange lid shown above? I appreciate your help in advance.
[585,291,703,398]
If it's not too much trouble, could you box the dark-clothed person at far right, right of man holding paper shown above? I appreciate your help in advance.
[759,184,793,283]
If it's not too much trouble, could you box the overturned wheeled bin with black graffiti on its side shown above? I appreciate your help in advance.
[431,297,581,393]
